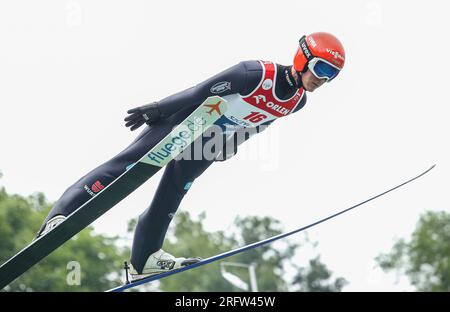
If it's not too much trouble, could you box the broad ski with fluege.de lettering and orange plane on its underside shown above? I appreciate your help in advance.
[0,96,227,289]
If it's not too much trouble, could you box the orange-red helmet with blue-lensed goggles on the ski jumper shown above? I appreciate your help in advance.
[294,32,345,81]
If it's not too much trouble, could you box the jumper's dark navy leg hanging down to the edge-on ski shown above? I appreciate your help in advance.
[131,130,227,273]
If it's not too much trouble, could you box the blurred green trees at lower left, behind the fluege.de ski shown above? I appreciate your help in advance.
[0,188,128,291]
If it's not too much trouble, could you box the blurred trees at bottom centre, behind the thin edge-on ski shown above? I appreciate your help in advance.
[130,211,346,292]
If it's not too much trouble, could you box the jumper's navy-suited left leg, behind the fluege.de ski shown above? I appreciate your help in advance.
[41,108,195,230]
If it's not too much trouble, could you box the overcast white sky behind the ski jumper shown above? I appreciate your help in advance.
[0,0,450,291]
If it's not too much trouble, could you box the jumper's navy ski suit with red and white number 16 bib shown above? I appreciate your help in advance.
[41,61,306,272]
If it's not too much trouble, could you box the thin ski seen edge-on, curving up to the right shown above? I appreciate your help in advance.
[107,165,436,292]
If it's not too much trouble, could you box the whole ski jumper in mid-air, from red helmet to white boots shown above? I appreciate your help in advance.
[38,32,345,279]
